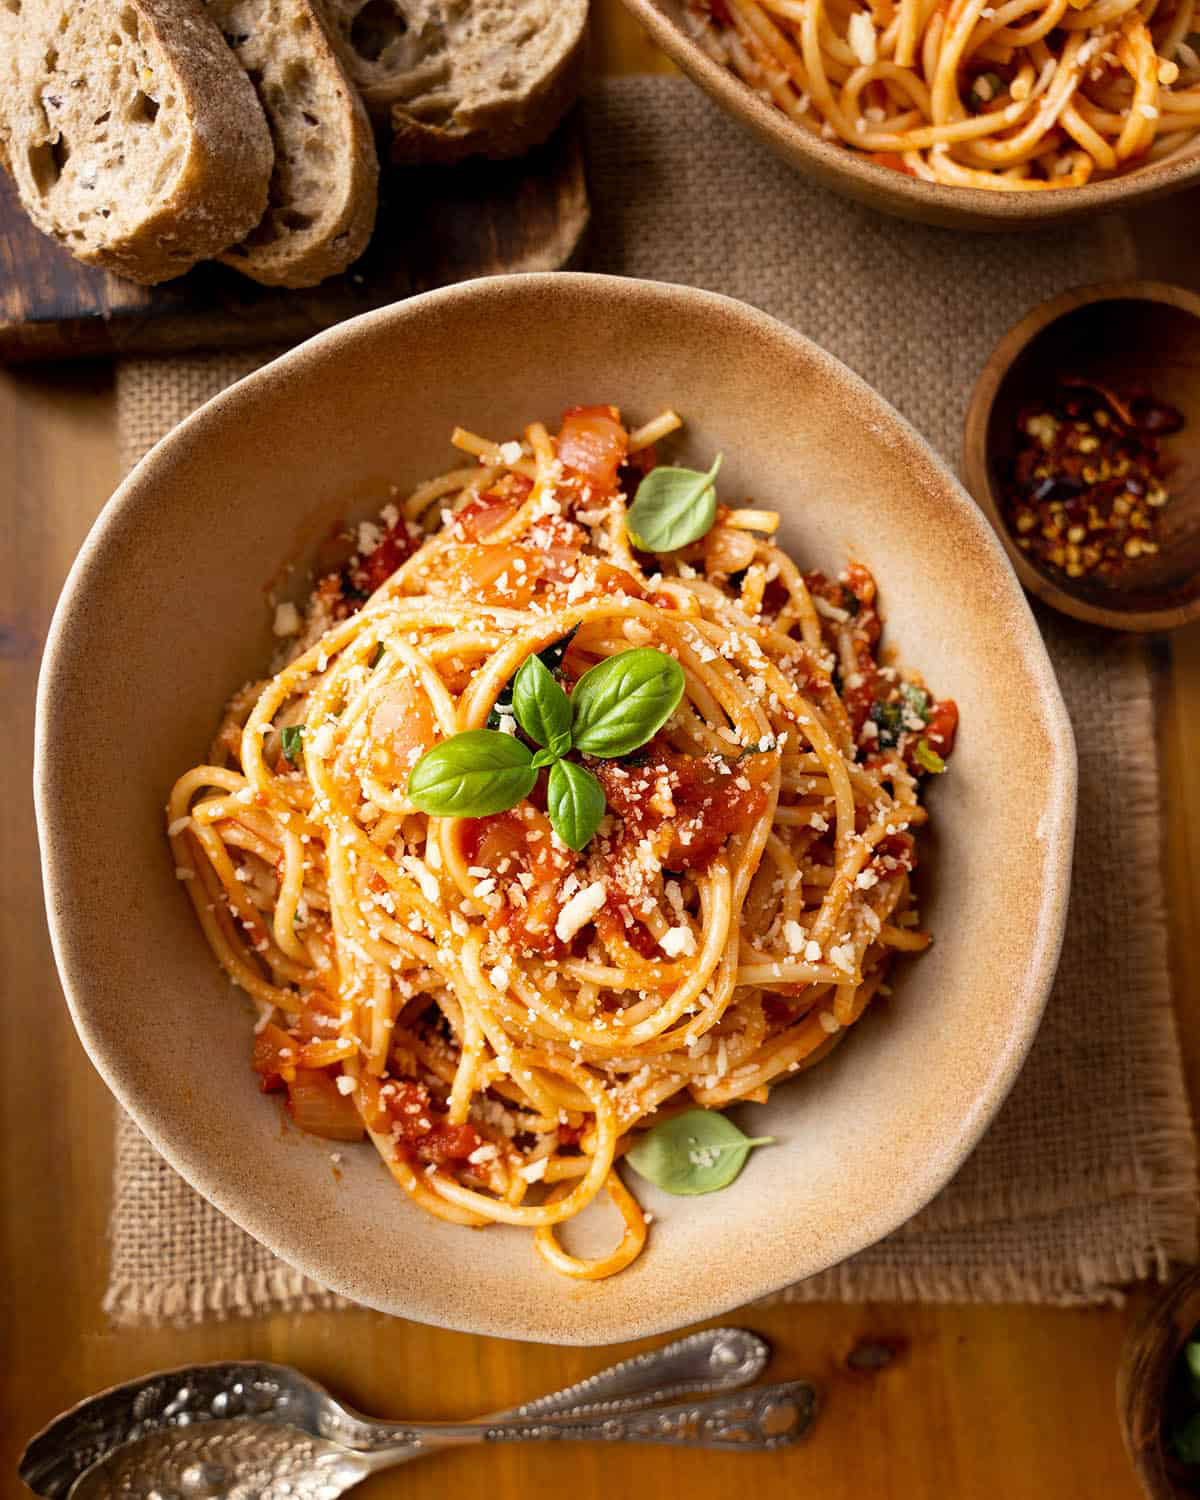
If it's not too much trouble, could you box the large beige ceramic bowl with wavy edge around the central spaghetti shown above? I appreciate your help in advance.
[36,275,1076,1344]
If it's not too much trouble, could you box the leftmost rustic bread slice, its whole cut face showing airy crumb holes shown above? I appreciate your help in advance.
[0,0,273,282]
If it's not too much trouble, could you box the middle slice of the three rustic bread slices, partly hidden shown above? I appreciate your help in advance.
[204,0,380,287]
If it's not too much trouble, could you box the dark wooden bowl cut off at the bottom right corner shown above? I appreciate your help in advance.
[1116,1266,1200,1500]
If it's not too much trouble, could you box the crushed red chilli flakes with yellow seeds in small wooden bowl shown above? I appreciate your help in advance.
[1001,377,1184,584]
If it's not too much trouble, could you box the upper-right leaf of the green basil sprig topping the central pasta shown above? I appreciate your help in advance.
[570,647,684,759]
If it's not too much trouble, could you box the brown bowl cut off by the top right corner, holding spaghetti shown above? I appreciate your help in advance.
[624,0,1200,230]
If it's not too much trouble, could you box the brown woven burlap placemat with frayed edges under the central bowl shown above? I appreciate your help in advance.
[105,78,1196,1323]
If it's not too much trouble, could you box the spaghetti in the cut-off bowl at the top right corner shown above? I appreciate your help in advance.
[686,0,1200,192]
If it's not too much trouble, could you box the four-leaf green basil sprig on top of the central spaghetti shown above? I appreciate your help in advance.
[408,647,684,851]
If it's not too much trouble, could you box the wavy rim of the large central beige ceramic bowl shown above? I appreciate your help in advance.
[35,272,1077,1344]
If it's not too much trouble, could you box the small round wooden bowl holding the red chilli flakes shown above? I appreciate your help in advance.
[963,282,1200,630]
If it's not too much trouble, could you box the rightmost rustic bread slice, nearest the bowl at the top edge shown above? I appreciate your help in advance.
[320,0,588,162]
